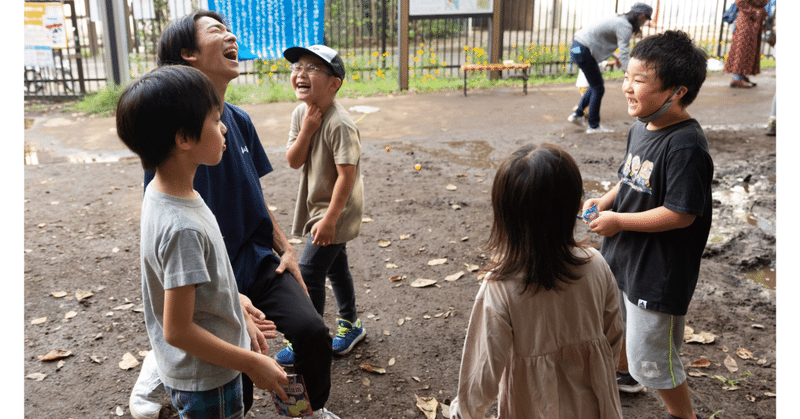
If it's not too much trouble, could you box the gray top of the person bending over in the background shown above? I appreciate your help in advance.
[574,15,633,71]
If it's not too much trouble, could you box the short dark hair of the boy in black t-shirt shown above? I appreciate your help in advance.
[631,31,708,108]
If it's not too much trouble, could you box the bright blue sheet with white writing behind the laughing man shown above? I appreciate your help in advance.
[208,0,325,60]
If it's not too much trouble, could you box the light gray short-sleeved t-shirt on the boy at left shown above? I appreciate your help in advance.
[141,187,250,391]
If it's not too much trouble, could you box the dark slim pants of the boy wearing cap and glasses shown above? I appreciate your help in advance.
[299,236,358,322]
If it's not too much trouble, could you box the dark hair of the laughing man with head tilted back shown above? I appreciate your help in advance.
[156,9,228,67]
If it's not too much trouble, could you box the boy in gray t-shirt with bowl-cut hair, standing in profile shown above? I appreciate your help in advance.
[117,66,289,418]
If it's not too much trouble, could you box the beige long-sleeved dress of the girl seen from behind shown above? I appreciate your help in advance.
[450,248,623,419]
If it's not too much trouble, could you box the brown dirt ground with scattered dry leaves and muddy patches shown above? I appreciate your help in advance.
[23,69,776,419]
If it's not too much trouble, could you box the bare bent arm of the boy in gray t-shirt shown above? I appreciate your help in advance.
[164,285,289,401]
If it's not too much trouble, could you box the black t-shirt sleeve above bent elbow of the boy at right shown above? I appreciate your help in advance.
[664,146,714,216]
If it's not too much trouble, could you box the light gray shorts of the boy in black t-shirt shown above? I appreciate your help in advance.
[619,292,686,390]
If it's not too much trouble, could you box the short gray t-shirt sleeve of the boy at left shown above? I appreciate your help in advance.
[159,230,211,290]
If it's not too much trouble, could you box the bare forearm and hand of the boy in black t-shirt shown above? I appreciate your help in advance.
[589,206,697,237]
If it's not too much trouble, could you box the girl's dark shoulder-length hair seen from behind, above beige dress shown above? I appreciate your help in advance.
[487,144,588,293]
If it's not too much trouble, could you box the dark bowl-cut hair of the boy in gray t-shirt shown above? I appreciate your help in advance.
[117,65,221,171]
